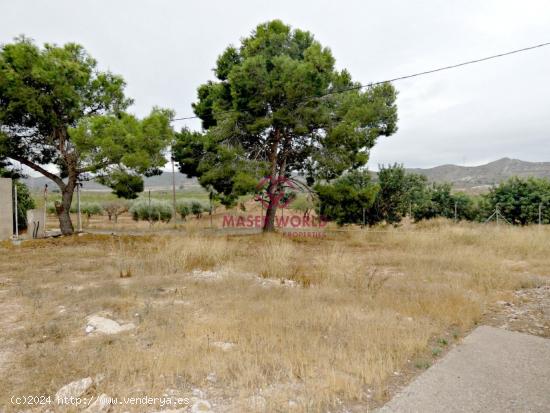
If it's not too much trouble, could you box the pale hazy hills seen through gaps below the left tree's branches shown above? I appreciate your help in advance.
[24,172,200,192]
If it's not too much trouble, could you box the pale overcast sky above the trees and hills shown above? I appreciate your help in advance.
[0,0,550,169]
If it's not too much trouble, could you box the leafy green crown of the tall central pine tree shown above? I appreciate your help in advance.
[174,20,397,222]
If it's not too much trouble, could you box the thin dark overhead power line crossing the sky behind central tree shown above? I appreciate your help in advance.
[172,42,550,121]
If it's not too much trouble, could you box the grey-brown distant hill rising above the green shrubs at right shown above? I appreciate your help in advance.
[407,158,550,188]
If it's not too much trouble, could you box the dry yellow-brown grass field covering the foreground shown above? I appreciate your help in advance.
[0,221,550,412]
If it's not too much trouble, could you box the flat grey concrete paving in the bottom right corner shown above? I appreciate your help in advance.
[378,326,550,413]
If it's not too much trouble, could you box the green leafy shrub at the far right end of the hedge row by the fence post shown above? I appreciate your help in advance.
[484,178,550,225]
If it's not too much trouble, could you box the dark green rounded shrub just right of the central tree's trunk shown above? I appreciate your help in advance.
[315,171,380,225]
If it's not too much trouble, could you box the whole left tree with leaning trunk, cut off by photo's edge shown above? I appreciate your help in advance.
[0,37,172,234]
